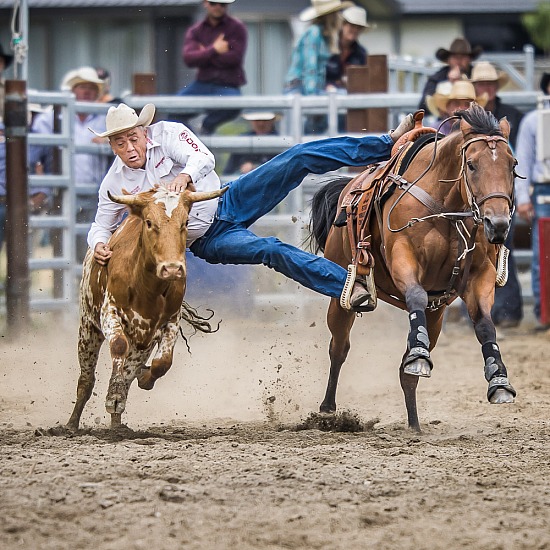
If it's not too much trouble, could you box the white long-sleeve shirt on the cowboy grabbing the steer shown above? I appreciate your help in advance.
[88,122,220,250]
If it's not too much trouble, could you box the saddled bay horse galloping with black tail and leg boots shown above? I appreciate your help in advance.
[310,102,516,432]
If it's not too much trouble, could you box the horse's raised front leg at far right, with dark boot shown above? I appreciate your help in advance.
[463,272,516,403]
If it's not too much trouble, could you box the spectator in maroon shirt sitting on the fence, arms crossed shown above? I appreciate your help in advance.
[178,0,248,135]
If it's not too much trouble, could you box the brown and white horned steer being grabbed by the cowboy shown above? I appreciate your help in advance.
[67,187,225,430]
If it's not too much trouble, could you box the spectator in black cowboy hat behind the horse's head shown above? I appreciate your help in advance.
[418,37,483,111]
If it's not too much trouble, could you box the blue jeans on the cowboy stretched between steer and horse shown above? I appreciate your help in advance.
[190,135,393,298]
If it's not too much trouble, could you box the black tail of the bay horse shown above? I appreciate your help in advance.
[309,176,353,253]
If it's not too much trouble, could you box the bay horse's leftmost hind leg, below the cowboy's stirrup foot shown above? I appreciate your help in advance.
[319,298,355,413]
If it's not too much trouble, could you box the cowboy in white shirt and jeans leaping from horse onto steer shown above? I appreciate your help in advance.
[88,103,414,311]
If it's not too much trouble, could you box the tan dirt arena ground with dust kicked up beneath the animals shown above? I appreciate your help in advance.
[0,301,550,550]
